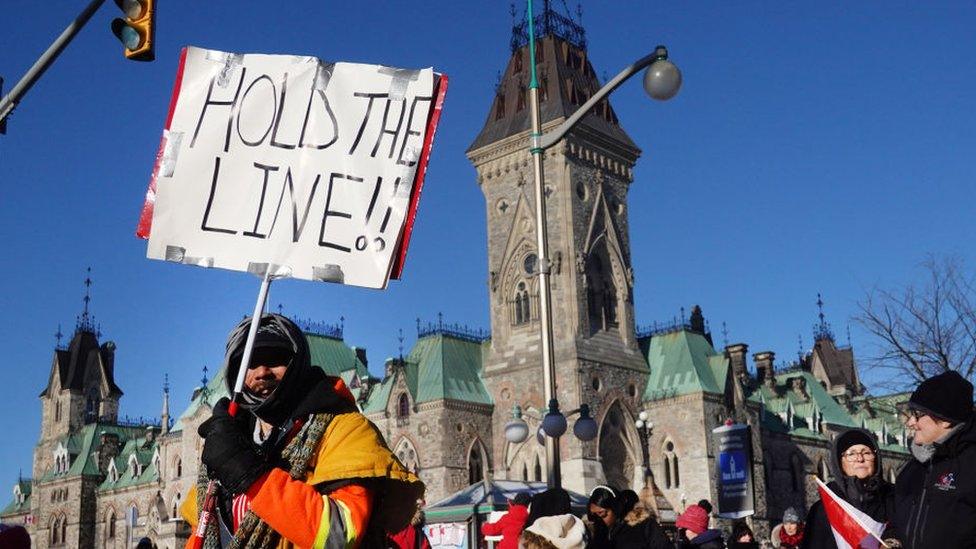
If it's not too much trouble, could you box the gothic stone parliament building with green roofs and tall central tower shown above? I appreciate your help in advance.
[0,6,909,549]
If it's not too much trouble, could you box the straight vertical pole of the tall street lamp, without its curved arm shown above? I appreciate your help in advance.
[526,0,562,488]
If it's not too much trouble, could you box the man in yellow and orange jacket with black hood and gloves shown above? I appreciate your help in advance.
[181,314,424,548]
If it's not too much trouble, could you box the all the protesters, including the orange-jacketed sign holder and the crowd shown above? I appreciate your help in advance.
[172,314,976,549]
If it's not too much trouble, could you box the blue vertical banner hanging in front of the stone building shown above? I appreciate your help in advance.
[712,424,755,519]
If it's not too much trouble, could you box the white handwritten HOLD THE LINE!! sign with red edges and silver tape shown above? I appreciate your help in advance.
[137,47,447,288]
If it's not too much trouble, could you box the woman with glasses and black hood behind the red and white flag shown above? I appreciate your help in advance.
[801,429,895,549]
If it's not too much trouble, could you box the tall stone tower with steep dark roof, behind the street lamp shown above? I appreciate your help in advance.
[467,3,647,492]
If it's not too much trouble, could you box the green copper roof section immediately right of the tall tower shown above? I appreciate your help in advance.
[639,329,729,400]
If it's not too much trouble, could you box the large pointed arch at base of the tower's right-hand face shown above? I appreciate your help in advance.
[599,400,640,488]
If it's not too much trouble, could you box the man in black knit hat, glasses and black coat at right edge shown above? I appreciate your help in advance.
[892,370,976,549]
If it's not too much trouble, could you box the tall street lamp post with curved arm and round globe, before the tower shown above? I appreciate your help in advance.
[526,0,681,488]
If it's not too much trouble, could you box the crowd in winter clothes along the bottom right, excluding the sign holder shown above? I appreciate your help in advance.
[485,371,976,549]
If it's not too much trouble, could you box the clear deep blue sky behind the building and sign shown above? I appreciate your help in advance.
[0,0,976,488]
